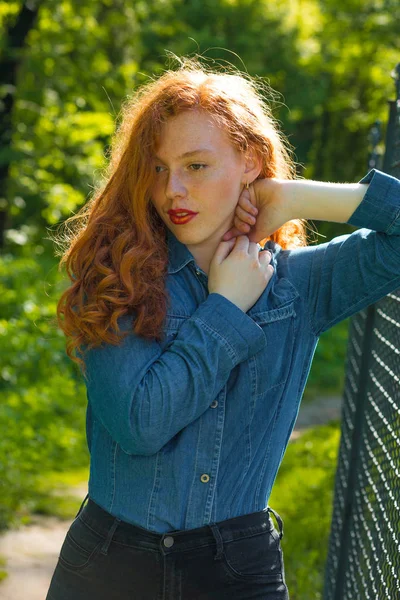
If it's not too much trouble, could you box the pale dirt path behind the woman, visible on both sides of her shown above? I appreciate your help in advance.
[0,397,341,600]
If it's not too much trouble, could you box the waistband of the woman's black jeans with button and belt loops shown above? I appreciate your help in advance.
[76,496,283,554]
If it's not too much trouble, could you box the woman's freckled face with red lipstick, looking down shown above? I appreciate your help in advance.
[151,110,248,250]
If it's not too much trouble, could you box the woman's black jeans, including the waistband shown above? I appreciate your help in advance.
[46,496,289,600]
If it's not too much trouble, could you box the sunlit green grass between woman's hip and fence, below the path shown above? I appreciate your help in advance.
[269,422,340,600]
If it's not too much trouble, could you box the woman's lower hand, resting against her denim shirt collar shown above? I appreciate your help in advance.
[208,235,274,312]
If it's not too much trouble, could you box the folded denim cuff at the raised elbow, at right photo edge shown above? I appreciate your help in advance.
[347,169,400,234]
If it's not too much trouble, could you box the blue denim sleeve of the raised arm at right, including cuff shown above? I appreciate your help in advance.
[283,169,400,336]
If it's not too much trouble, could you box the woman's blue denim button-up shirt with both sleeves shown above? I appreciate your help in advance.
[81,169,400,533]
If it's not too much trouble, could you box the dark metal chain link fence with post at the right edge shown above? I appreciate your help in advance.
[324,64,400,600]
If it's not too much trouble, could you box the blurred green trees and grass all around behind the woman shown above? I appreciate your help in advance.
[0,0,400,600]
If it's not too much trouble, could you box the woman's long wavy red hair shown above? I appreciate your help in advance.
[55,58,307,373]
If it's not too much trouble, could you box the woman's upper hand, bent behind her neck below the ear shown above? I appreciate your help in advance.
[222,178,293,243]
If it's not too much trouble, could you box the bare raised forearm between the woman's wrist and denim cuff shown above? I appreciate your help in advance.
[284,179,368,223]
